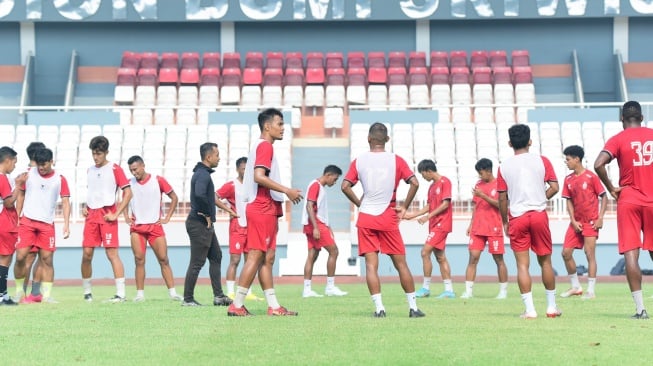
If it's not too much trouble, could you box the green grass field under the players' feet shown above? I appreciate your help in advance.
[0,282,653,365]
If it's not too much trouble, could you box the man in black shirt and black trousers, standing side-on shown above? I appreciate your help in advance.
[181,142,231,306]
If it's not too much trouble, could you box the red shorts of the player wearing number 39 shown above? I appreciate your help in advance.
[617,201,653,254]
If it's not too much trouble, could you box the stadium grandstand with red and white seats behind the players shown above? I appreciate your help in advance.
[0,0,653,278]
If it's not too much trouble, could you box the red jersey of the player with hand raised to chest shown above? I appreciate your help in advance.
[471,179,503,236]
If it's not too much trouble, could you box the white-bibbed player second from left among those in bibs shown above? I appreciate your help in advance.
[82,136,132,303]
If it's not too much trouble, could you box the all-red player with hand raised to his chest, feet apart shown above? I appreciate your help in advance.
[460,158,508,299]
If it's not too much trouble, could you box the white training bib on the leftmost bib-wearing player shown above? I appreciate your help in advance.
[23,169,61,224]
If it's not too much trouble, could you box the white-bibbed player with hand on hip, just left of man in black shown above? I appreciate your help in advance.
[124,155,183,302]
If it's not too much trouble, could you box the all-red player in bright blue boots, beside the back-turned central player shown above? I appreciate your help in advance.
[404,159,456,299]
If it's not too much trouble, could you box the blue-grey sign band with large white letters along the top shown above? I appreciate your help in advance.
[0,0,653,22]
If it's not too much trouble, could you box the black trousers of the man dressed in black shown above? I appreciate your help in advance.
[184,219,224,301]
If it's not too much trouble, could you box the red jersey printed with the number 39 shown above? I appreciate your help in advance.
[603,127,653,206]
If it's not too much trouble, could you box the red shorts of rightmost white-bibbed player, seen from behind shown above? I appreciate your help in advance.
[508,211,553,255]
